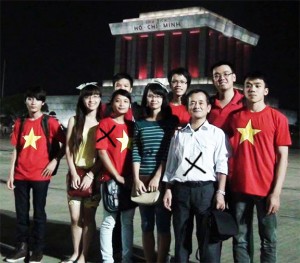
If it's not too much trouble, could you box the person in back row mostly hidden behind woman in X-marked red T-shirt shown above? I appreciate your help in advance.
[102,73,142,121]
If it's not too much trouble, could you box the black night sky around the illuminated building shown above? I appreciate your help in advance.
[1,1,300,109]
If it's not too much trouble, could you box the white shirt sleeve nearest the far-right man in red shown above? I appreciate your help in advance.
[215,129,231,174]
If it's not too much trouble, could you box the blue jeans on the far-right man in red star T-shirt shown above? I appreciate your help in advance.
[232,194,277,263]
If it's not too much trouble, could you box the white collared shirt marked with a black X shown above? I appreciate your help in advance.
[163,121,230,185]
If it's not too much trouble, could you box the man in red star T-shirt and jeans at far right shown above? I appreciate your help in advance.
[228,72,291,263]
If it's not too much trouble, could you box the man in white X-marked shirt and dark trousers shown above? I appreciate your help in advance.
[163,89,229,262]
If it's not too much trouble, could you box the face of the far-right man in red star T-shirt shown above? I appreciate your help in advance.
[244,78,269,104]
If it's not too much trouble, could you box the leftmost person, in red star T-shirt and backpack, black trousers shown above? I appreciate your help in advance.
[6,87,65,262]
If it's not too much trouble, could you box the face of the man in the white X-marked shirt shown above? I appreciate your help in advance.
[188,92,211,120]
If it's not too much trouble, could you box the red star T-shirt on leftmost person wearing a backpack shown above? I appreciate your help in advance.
[11,116,66,181]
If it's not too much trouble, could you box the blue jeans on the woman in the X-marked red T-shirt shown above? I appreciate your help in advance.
[100,208,135,263]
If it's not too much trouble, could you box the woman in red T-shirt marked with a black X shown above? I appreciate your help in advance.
[96,89,135,262]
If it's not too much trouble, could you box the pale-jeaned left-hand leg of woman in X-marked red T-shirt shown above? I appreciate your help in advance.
[100,206,117,263]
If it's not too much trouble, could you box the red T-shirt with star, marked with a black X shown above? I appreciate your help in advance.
[96,117,133,181]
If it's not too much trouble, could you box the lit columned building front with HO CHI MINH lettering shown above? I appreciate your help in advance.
[109,7,259,88]
